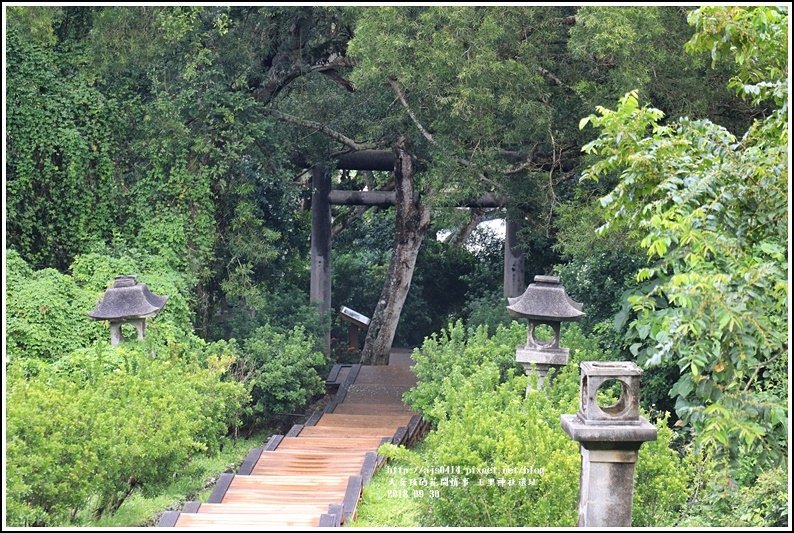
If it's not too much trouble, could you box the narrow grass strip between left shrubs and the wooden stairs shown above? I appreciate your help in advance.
[80,433,268,527]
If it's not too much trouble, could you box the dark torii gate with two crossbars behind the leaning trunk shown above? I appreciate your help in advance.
[309,150,526,355]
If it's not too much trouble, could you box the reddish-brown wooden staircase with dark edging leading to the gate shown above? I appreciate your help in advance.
[159,350,426,529]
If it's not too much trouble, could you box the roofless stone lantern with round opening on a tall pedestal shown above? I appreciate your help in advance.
[560,361,656,527]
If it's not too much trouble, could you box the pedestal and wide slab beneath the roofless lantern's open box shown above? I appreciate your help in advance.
[560,415,656,527]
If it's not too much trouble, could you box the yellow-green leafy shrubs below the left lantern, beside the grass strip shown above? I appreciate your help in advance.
[6,345,245,526]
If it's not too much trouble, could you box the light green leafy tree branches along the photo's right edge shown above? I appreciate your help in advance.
[582,3,788,473]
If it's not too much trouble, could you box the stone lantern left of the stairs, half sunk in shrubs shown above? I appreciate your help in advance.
[88,276,168,346]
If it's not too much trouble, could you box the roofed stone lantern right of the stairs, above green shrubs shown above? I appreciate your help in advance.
[507,276,584,393]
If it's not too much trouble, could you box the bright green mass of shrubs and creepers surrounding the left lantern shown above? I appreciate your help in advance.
[6,250,246,525]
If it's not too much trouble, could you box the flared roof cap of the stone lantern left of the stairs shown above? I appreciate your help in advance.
[88,276,168,320]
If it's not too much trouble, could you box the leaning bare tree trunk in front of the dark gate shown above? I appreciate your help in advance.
[361,137,430,365]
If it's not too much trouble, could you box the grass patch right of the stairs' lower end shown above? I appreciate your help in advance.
[350,444,423,527]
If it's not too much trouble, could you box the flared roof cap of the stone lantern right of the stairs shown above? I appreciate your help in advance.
[507,276,585,322]
